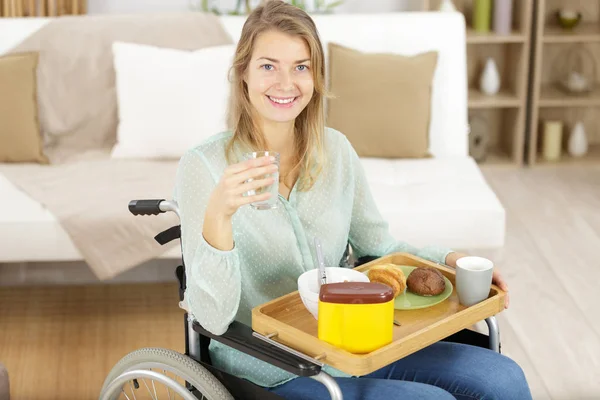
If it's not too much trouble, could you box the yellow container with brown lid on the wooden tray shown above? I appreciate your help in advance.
[318,282,394,353]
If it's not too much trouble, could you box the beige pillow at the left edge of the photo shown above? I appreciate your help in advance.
[0,53,48,164]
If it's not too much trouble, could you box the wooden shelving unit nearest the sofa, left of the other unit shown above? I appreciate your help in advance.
[423,0,534,166]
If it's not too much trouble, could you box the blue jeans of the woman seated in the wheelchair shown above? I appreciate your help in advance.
[270,342,531,400]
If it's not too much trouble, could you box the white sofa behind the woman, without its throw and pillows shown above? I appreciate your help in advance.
[0,13,505,268]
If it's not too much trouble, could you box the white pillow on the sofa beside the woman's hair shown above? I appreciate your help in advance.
[111,42,235,159]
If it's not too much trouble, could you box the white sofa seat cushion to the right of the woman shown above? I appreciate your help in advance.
[361,157,505,250]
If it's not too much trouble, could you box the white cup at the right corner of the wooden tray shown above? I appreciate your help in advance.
[456,257,494,307]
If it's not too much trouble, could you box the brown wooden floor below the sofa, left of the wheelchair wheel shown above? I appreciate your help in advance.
[0,283,184,400]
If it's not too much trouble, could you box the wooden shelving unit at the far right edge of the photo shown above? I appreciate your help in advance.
[526,0,600,165]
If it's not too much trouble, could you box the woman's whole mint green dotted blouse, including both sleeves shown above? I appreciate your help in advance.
[174,128,450,387]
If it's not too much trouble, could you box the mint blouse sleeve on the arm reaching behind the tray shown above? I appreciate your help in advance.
[346,140,452,264]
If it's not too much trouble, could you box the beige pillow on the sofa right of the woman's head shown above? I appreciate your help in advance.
[327,43,438,158]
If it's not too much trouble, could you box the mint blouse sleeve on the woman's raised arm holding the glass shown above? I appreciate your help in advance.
[175,149,241,335]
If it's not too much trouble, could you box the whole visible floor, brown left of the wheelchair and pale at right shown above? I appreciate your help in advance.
[0,166,600,400]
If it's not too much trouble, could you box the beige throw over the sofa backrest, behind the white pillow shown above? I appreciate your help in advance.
[8,12,231,163]
